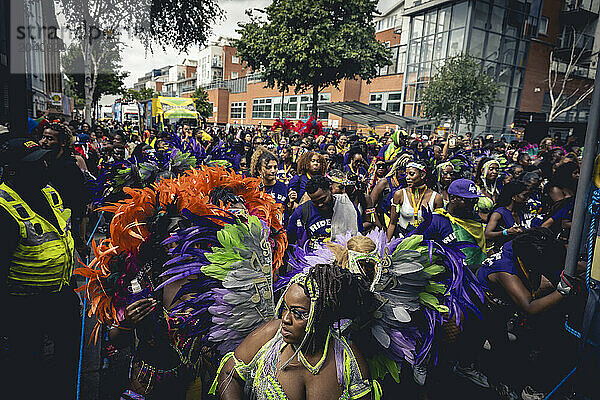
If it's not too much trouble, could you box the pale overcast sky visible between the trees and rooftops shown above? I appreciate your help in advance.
[122,0,398,87]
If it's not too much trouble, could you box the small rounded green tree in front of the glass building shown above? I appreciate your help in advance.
[422,54,500,132]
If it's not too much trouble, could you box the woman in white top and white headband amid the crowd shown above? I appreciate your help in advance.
[387,161,444,240]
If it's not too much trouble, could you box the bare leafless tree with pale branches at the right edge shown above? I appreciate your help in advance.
[548,29,594,122]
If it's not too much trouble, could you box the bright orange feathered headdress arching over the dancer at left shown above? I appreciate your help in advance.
[75,167,287,342]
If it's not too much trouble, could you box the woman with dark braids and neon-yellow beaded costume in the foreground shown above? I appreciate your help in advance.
[211,264,379,400]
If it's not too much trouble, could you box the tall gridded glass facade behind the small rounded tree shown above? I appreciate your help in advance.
[403,0,541,133]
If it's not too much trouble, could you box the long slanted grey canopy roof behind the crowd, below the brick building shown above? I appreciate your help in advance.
[319,101,432,128]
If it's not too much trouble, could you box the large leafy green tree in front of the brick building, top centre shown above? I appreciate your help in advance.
[235,0,391,122]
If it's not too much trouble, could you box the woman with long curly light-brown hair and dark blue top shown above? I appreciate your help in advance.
[250,146,287,204]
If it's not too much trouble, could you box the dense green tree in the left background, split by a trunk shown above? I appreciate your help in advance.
[62,44,128,114]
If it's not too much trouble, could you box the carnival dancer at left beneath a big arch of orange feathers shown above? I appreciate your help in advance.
[76,167,287,399]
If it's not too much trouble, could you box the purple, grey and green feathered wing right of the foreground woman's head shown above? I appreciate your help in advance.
[371,230,483,365]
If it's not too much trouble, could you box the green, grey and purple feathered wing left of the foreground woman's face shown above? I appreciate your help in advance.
[163,216,275,355]
